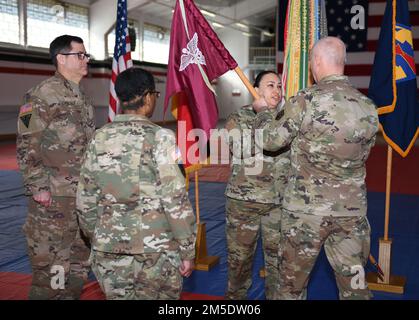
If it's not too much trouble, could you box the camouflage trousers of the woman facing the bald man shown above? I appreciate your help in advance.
[226,198,281,300]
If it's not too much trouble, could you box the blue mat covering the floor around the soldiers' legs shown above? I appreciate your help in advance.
[0,171,419,300]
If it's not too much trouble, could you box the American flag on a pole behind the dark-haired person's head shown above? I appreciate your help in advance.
[108,0,132,122]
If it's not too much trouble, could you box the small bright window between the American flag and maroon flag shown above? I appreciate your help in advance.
[141,24,170,64]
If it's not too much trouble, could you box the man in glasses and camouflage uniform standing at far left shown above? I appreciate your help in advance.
[17,35,95,299]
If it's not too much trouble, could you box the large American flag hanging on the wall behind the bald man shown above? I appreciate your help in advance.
[277,0,419,94]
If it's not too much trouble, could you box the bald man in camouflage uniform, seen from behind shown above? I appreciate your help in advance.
[254,37,378,299]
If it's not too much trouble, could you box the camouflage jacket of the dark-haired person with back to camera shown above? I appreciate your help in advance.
[77,115,196,259]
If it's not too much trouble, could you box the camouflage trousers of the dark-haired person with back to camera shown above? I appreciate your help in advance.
[90,250,183,300]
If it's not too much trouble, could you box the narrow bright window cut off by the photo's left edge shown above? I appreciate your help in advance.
[0,0,19,44]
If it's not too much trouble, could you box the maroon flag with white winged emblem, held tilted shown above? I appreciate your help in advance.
[164,0,237,139]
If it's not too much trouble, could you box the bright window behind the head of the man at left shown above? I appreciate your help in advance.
[27,0,89,51]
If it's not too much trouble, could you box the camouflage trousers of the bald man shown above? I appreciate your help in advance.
[278,210,371,300]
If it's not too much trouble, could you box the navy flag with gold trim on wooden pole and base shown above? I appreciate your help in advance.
[367,0,408,294]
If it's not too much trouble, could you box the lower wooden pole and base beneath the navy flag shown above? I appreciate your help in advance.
[367,146,406,294]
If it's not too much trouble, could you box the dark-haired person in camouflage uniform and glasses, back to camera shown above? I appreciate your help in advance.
[77,68,196,299]
